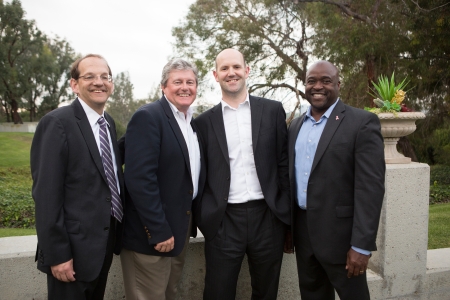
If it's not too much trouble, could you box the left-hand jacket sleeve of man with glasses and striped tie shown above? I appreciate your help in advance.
[30,115,73,271]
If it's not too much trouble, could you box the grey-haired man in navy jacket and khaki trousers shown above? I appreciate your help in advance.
[121,59,202,300]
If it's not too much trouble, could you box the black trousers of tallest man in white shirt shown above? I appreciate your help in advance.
[203,200,285,300]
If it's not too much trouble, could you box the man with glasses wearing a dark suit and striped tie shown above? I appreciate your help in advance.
[31,54,124,300]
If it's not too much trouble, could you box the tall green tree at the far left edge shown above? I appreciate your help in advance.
[0,0,43,124]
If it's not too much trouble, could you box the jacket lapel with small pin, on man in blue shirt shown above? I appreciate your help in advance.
[311,100,345,173]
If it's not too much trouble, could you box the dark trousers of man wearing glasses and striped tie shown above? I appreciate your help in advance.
[47,217,116,300]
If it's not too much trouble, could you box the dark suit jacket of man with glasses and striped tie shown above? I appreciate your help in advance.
[31,99,124,281]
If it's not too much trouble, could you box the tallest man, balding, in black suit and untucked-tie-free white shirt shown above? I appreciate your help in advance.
[194,49,290,300]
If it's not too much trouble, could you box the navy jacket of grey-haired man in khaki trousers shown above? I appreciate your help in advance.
[123,97,204,256]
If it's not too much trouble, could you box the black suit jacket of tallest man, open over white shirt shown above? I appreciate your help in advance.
[194,96,290,240]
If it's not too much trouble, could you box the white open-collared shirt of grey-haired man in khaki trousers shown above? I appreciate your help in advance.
[164,96,200,199]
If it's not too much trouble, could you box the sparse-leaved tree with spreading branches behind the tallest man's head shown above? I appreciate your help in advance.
[172,0,309,119]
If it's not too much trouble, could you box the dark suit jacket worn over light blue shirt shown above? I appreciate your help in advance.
[289,101,386,263]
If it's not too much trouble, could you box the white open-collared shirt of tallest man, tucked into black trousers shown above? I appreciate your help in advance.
[221,94,264,203]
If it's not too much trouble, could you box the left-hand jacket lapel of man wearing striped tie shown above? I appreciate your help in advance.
[71,98,110,184]
